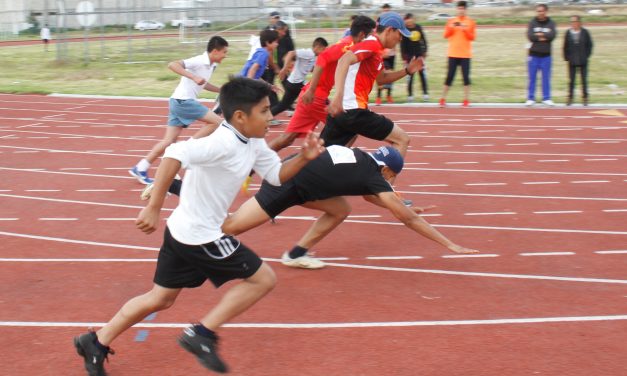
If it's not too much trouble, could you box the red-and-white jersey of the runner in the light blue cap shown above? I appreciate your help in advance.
[342,35,384,110]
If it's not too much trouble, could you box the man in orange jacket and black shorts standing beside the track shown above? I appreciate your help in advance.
[440,1,475,107]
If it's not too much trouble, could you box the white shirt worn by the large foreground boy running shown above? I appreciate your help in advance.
[163,122,281,245]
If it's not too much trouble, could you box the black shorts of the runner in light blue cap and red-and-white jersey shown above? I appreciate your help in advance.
[320,108,394,146]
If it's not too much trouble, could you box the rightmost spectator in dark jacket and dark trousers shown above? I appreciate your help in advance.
[564,16,592,106]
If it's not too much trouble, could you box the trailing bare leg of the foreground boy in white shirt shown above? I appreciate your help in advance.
[96,285,181,346]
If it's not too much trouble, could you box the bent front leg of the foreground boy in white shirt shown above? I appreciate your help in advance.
[200,263,276,331]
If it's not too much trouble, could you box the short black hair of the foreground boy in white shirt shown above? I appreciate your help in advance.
[220,76,272,121]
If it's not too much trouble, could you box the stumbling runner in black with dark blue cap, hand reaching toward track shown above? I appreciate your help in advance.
[222,145,477,269]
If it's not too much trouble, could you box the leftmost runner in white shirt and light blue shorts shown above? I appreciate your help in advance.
[128,36,229,184]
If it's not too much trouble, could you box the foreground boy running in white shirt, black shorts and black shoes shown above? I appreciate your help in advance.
[74,77,325,375]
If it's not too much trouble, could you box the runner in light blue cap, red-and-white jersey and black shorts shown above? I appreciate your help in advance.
[320,12,422,161]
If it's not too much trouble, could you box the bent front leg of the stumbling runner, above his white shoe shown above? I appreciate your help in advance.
[296,197,351,249]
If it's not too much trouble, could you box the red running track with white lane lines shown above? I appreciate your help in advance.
[0,95,627,376]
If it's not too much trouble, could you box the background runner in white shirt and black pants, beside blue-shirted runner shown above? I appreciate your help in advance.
[271,37,329,116]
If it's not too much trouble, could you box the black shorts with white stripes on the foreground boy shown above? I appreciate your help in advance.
[153,227,263,289]
